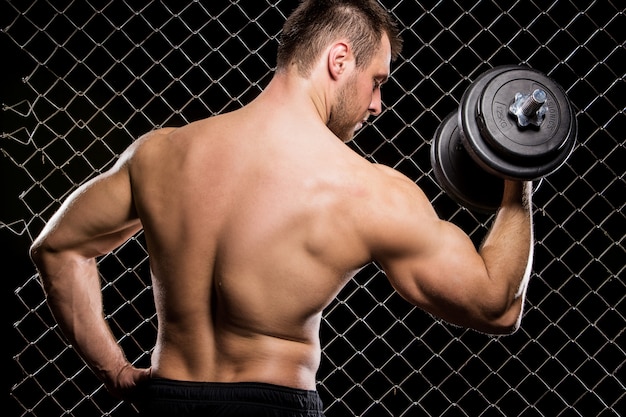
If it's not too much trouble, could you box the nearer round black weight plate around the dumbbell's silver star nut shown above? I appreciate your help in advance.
[459,66,576,180]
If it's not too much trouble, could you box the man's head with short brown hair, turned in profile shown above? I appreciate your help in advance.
[277,0,402,142]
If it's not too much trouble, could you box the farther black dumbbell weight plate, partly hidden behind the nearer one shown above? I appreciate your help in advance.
[430,112,504,213]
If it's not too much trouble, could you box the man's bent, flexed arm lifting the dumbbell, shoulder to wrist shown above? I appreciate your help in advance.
[368,164,533,334]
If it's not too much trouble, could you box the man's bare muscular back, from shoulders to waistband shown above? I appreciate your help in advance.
[130,111,373,389]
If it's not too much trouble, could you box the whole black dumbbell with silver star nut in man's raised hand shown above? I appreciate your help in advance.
[430,65,578,213]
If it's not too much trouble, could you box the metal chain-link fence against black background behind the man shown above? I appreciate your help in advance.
[0,0,626,417]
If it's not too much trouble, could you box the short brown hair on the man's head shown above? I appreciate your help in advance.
[276,0,402,76]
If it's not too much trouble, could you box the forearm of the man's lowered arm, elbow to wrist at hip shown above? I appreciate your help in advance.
[34,252,129,386]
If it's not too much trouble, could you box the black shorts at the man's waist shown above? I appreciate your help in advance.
[133,378,324,417]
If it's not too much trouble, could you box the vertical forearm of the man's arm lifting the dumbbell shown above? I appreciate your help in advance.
[479,181,534,329]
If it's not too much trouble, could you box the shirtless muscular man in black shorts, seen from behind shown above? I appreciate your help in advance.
[31,0,532,417]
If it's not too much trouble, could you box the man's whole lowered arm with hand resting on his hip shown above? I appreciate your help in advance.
[31,145,149,398]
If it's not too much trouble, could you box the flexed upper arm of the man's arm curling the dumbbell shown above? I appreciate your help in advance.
[370,166,510,328]
